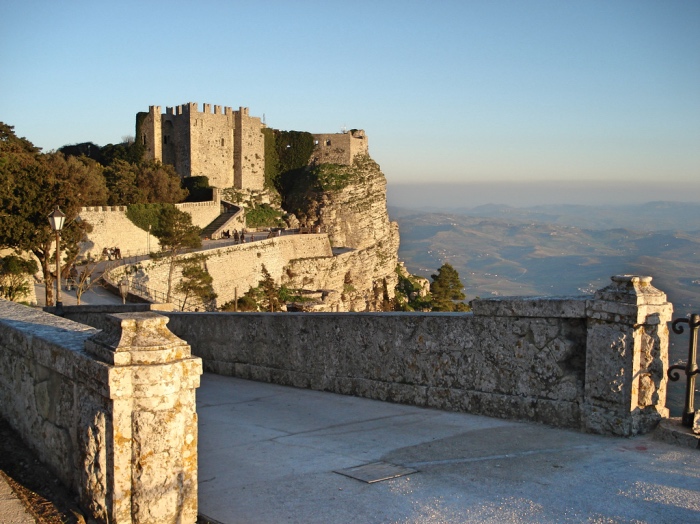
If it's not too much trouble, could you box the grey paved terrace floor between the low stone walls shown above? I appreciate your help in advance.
[197,374,700,524]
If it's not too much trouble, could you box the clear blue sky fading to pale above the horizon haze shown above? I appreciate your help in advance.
[0,0,700,196]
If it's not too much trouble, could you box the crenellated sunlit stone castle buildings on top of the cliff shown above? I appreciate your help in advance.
[136,102,368,190]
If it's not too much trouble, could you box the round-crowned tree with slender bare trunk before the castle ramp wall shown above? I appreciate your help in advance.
[153,206,202,302]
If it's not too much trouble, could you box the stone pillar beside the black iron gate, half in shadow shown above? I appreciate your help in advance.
[582,275,673,436]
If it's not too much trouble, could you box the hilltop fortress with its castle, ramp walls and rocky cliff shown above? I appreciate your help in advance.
[81,103,399,311]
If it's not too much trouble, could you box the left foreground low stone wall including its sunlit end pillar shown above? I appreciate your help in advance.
[0,301,201,523]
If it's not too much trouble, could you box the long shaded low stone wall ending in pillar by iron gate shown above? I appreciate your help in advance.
[166,276,672,435]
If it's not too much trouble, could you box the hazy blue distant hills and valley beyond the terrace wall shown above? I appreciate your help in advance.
[390,203,700,414]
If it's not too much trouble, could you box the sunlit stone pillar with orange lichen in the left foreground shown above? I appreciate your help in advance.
[77,312,202,524]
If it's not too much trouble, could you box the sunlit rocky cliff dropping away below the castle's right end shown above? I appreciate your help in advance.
[282,155,399,311]
